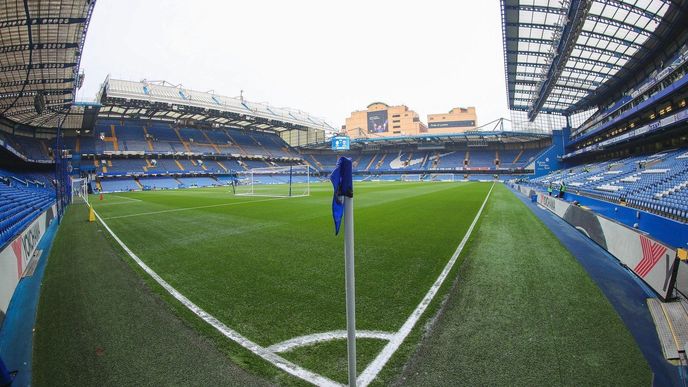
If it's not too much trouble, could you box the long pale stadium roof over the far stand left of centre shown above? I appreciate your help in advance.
[99,78,334,132]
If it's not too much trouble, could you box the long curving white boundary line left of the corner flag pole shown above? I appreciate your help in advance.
[94,211,342,386]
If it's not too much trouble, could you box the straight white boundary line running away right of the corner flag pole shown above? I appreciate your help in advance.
[357,183,495,387]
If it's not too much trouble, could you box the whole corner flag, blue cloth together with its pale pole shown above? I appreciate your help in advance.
[330,157,357,387]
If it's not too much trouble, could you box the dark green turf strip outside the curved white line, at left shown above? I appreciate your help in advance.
[32,205,267,386]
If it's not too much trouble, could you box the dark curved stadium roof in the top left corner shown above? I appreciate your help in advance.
[0,0,95,128]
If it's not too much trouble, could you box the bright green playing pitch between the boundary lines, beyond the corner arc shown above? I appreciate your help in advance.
[93,183,490,382]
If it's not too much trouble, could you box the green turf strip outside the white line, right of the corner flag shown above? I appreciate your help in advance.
[399,186,651,386]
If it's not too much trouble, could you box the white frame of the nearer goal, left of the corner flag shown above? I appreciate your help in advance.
[232,164,311,198]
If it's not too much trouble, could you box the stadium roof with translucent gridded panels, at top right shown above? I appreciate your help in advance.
[501,0,686,119]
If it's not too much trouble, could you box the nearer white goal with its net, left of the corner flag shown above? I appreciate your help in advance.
[232,165,311,197]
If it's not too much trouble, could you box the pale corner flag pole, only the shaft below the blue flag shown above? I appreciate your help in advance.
[344,197,357,387]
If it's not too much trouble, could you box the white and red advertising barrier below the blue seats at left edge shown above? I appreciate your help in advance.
[0,205,57,325]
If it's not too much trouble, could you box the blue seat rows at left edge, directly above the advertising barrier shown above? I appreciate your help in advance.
[0,178,55,246]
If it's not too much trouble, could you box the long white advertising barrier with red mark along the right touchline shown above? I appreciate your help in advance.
[516,185,685,301]
